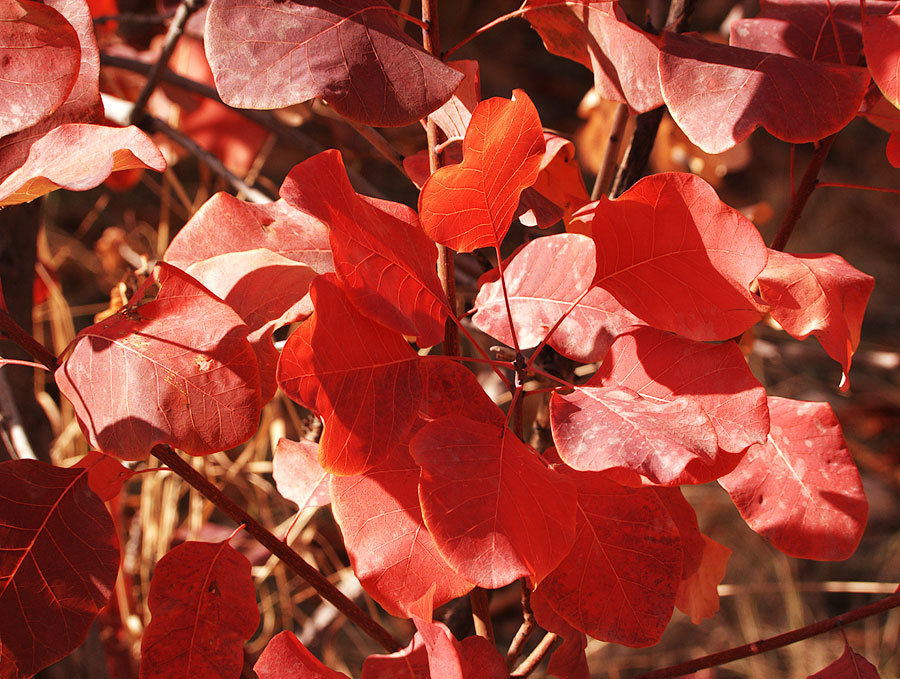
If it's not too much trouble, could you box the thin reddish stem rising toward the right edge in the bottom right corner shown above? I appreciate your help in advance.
[633,592,900,679]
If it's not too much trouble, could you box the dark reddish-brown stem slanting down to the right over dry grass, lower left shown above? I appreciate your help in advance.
[150,444,402,653]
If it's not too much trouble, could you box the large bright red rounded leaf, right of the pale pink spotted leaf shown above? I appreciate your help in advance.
[591,172,767,340]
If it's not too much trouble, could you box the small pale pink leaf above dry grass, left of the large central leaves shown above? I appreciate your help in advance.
[272,439,331,509]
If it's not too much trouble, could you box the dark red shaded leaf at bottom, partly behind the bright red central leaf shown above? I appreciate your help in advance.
[536,467,682,646]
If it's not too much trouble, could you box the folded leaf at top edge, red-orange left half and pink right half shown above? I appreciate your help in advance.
[522,0,662,113]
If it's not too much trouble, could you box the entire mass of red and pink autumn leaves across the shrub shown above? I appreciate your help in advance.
[0,0,900,679]
